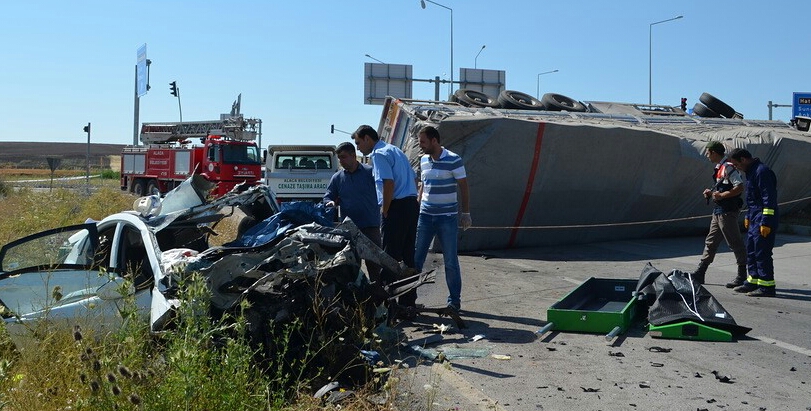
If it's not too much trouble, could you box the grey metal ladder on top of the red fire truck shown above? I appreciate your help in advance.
[141,117,262,144]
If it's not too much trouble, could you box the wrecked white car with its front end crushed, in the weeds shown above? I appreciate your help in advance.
[0,177,431,364]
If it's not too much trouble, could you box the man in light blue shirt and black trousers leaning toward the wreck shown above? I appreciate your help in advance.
[352,125,419,307]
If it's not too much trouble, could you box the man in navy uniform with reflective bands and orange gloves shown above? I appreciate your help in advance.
[729,148,778,297]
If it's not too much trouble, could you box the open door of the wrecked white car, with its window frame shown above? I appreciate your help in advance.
[0,223,136,342]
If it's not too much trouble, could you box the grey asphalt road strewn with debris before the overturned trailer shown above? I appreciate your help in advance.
[390,233,811,411]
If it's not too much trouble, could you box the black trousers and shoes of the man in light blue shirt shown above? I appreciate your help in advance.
[380,196,420,306]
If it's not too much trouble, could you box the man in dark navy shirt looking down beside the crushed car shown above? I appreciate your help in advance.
[324,142,382,282]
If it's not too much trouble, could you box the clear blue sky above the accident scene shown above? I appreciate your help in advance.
[0,0,811,146]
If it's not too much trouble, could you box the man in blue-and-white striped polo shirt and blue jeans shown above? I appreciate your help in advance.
[414,126,472,311]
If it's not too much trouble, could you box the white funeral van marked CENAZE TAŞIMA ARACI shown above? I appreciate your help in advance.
[265,145,339,204]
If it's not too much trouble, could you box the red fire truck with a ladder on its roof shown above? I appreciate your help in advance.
[121,116,263,197]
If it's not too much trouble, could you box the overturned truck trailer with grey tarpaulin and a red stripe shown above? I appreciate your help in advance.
[378,98,811,251]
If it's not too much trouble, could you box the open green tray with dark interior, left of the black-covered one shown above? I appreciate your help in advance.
[546,277,637,333]
